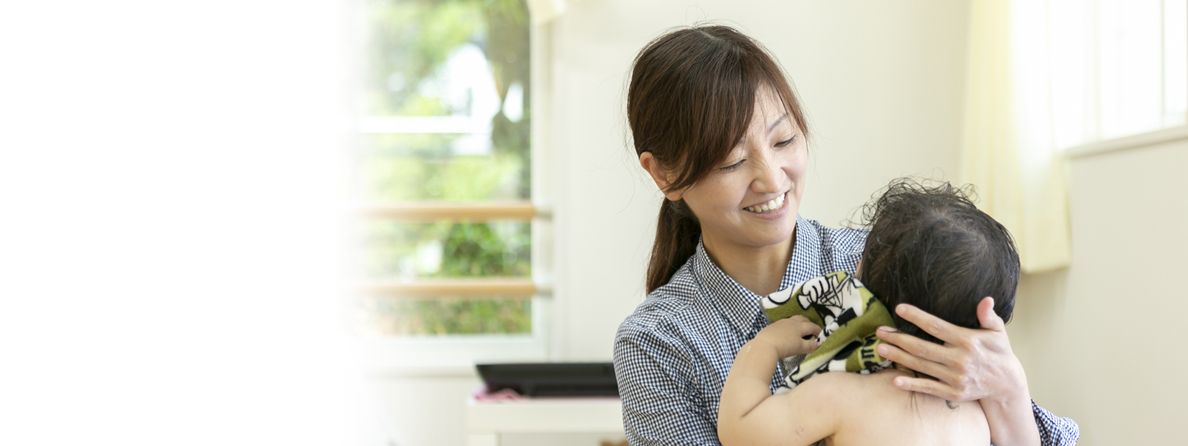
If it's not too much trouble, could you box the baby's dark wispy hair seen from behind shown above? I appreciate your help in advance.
[859,178,1019,343]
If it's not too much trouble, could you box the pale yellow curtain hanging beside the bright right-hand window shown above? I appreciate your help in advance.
[959,0,1069,272]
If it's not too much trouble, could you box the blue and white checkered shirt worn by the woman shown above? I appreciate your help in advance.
[614,218,1080,445]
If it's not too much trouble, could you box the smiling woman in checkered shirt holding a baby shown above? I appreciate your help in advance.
[614,26,1078,445]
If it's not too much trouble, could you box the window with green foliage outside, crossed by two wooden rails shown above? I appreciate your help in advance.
[356,0,549,363]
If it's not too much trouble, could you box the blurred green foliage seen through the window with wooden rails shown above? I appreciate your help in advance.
[359,0,531,334]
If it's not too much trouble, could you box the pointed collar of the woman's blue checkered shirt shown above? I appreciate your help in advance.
[693,215,821,334]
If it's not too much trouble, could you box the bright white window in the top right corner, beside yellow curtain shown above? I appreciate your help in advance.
[1031,0,1188,147]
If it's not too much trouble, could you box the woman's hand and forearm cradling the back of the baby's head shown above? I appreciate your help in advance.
[878,297,1076,445]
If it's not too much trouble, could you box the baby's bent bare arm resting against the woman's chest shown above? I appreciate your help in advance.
[718,316,836,445]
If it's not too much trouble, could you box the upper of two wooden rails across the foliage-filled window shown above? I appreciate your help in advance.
[362,201,551,221]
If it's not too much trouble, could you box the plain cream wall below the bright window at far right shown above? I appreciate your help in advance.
[1007,139,1188,445]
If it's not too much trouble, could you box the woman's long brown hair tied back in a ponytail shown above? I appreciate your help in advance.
[627,26,808,293]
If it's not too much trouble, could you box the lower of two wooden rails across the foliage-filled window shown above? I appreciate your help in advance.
[361,277,551,299]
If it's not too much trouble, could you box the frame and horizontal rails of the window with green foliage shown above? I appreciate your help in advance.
[355,6,558,376]
